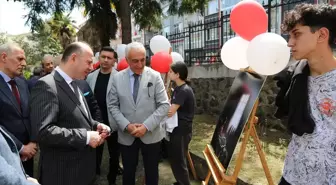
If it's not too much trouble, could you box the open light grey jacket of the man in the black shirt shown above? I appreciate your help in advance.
[86,68,118,131]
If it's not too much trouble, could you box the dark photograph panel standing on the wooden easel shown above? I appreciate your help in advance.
[211,72,266,169]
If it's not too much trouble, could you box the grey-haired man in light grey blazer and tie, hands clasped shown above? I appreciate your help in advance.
[107,42,169,185]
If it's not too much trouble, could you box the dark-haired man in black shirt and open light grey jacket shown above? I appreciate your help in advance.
[86,46,120,185]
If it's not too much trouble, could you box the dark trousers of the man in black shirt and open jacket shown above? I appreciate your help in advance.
[96,132,120,184]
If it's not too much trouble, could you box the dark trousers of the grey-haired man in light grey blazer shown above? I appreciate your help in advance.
[120,138,161,185]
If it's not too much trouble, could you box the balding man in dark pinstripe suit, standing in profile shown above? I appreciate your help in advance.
[30,42,110,185]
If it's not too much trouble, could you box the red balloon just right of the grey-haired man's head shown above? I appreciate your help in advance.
[151,52,173,73]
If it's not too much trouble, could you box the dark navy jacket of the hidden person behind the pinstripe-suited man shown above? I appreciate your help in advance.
[77,80,103,123]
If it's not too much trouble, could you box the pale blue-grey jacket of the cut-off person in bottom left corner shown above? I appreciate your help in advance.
[0,127,36,185]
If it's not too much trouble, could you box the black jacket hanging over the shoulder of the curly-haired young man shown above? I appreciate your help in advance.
[274,61,315,136]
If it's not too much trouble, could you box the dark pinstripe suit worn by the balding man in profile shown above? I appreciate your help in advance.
[30,70,98,185]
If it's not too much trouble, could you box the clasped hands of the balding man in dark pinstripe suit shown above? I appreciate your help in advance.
[88,123,111,148]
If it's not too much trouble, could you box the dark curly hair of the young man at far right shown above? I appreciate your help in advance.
[281,3,336,47]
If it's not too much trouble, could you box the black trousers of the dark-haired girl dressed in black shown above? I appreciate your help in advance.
[168,132,191,185]
